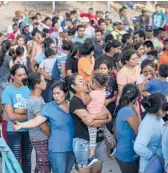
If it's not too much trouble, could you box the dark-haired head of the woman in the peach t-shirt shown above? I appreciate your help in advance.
[122,49,138,68]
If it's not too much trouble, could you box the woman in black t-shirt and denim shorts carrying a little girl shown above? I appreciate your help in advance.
[69,74,111,173]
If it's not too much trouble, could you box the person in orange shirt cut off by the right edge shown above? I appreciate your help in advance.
[158,39,168,69]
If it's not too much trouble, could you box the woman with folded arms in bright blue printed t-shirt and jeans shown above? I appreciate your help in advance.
[2,64,32,173]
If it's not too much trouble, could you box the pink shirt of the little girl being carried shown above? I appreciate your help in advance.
[87,90,105,114]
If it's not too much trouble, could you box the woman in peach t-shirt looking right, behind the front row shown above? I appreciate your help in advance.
[117,49,141,96]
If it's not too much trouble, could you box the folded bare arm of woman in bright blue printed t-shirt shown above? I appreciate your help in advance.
[4,104,27,121]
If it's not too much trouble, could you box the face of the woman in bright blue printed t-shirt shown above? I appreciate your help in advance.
[12,68,27,86]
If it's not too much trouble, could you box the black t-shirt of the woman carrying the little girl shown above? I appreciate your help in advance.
[69,96,104,142]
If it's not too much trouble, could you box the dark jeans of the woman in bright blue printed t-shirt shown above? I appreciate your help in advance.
[7,132,33,173]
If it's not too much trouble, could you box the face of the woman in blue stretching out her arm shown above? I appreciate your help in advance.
[53,87,66,105]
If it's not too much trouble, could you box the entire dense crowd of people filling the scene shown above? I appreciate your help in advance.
[0,4,168,173]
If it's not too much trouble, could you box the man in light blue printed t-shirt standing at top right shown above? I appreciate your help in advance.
[152,4,165,36]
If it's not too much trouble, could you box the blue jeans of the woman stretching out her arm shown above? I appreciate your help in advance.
[48,151,75,173]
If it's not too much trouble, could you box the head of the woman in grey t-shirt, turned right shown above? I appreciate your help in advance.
[28,72,46,91]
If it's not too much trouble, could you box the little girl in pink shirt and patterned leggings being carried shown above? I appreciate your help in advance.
[82,73,113,166]
